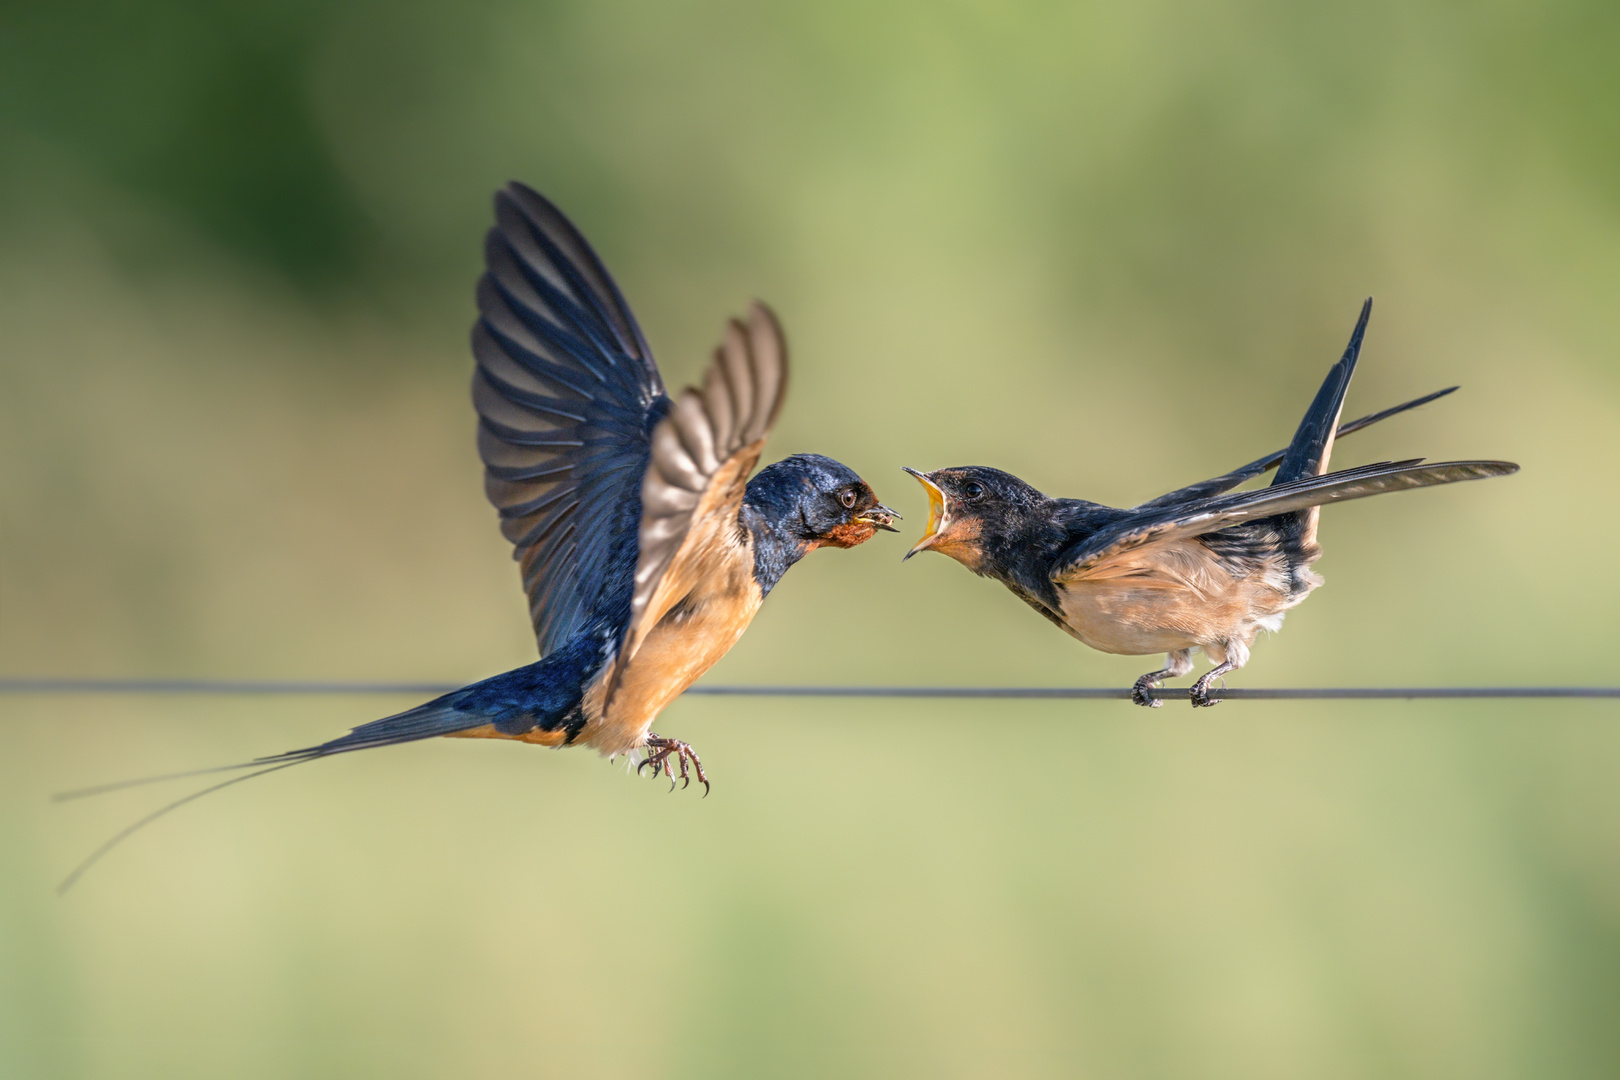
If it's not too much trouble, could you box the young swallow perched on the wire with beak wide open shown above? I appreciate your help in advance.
[906,300,1518,708]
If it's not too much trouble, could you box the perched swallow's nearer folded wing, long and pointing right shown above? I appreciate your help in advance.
[1050,458,1518,583]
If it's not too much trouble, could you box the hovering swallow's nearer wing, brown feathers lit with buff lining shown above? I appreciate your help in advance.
[619,301,787,662]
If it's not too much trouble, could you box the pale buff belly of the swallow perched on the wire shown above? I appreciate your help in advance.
[1056,539,1320,664]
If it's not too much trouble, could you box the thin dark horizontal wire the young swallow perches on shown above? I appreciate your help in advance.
[0,678,1620,701]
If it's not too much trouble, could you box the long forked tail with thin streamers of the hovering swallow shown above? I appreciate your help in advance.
[53,687,489,895]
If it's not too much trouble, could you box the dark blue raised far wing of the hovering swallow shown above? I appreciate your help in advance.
[473,183,669,656]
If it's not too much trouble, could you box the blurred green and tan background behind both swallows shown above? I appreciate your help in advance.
[0,0,1620,1080]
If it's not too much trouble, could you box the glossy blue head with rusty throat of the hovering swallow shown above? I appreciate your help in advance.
[748,453,901,551]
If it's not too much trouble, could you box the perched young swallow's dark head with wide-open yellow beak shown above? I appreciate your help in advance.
[901,465,1045,573]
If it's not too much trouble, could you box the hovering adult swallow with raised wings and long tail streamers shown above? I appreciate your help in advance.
[63,183,899,887]
